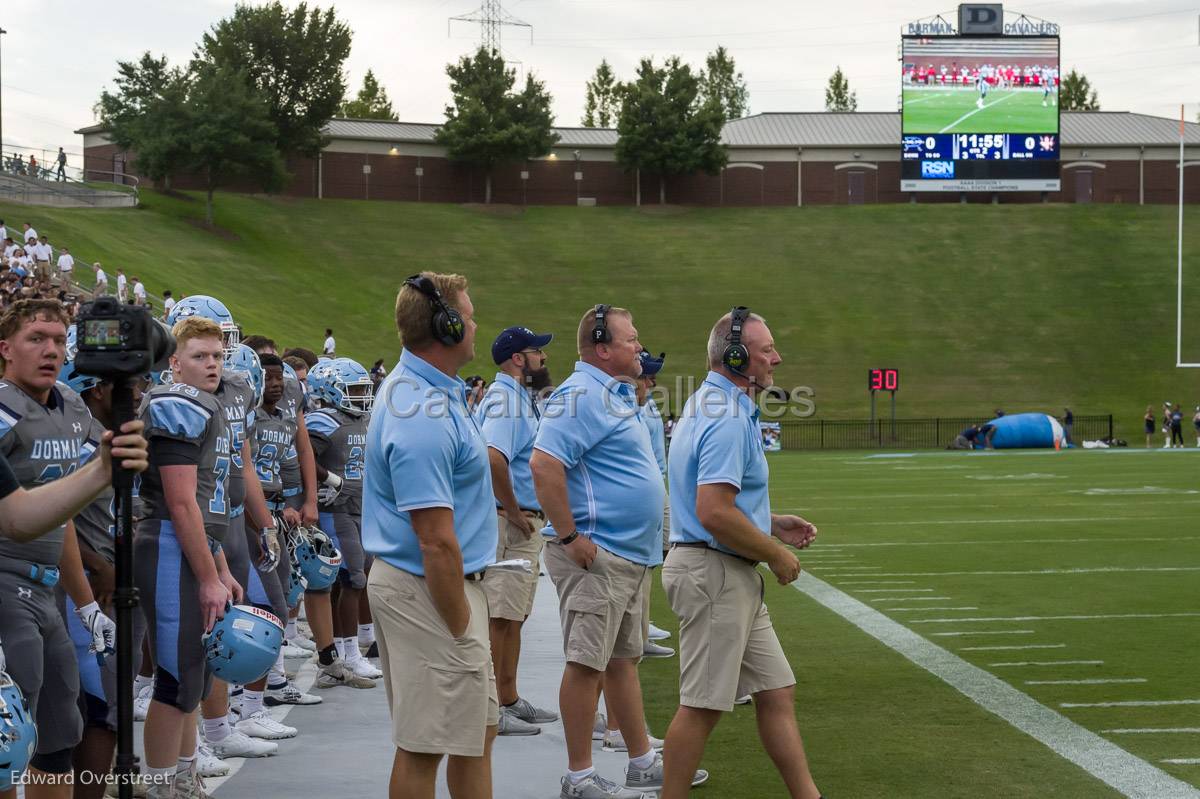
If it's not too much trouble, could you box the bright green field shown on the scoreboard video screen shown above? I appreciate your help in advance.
[904,89,1058,133]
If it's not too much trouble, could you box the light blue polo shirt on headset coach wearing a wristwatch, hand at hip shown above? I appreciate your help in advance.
[534,361,664,566]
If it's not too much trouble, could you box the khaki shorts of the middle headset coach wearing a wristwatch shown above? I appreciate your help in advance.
[546,543,650,672]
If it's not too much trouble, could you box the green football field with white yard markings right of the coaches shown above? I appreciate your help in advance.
[641,440,1200,799]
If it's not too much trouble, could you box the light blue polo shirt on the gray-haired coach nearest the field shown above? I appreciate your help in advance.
[667,372,770,552]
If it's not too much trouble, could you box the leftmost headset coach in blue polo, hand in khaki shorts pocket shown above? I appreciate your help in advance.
[362,272,499,799]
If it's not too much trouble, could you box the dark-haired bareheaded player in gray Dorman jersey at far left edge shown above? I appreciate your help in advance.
[0,300,116,798]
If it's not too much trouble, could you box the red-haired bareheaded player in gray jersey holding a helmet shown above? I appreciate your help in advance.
[133,317,242,797]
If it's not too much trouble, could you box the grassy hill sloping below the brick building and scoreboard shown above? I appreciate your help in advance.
[0,192,1200,438]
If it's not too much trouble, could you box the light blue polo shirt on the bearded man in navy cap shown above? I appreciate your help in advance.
[475,372,541,510]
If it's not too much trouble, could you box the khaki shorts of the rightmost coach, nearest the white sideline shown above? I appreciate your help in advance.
[662,547,796,711]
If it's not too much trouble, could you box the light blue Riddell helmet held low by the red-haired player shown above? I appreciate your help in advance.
[203,605,283,685]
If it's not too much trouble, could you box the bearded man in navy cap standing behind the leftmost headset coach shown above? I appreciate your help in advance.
[475,328,558,735]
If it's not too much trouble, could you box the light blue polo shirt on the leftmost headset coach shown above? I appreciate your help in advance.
[362,350,497,576]
